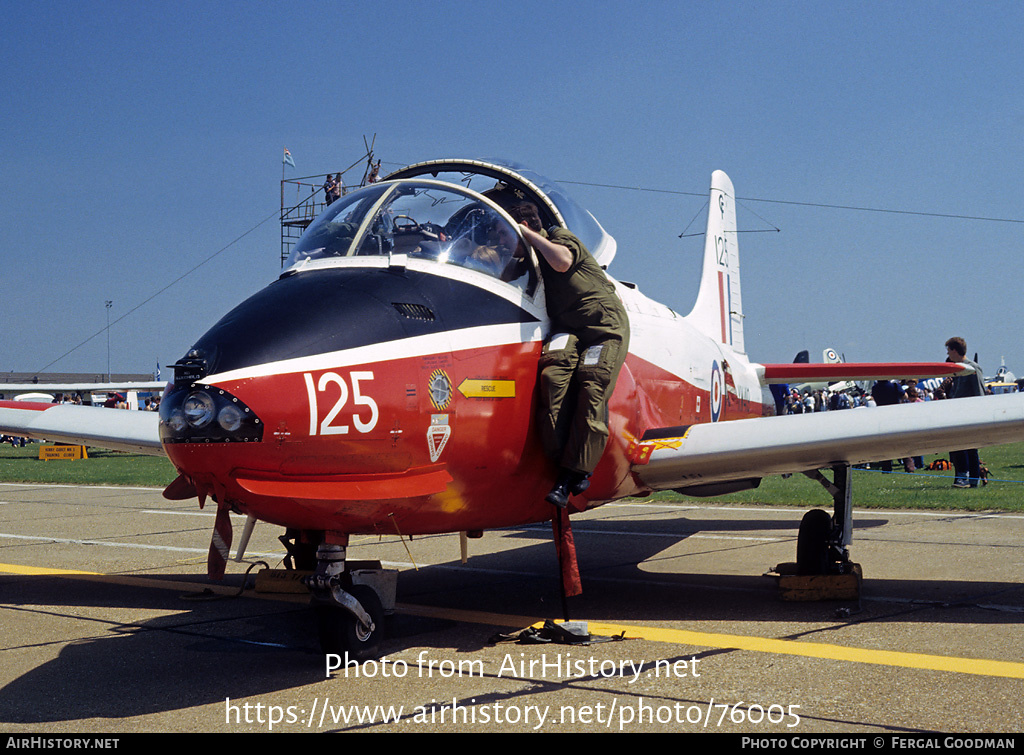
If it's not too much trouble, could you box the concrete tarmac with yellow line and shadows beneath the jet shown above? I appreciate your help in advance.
[0,484,1024,738]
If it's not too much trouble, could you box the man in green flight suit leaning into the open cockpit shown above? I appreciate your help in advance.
[509,202,630,508]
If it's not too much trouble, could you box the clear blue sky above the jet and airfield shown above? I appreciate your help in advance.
[0,0,1024,376]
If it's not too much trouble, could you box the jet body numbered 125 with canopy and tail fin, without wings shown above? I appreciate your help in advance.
[161,161,771,535]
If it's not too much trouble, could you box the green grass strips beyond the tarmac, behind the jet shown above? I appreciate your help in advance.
[0,443,1024,511]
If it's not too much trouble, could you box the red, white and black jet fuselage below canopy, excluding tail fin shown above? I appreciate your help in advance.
[162,261,764,535]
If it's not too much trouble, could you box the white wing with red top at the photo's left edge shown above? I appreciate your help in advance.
[0,401,164,456]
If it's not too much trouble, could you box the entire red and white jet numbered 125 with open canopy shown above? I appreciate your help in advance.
[0,160,1024,656]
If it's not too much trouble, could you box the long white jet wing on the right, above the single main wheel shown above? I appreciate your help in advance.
[633,391,1024,490]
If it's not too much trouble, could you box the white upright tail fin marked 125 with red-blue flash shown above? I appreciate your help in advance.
[687,170,745,353]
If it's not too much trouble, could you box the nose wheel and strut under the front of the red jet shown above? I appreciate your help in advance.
[303,543,398,661]
